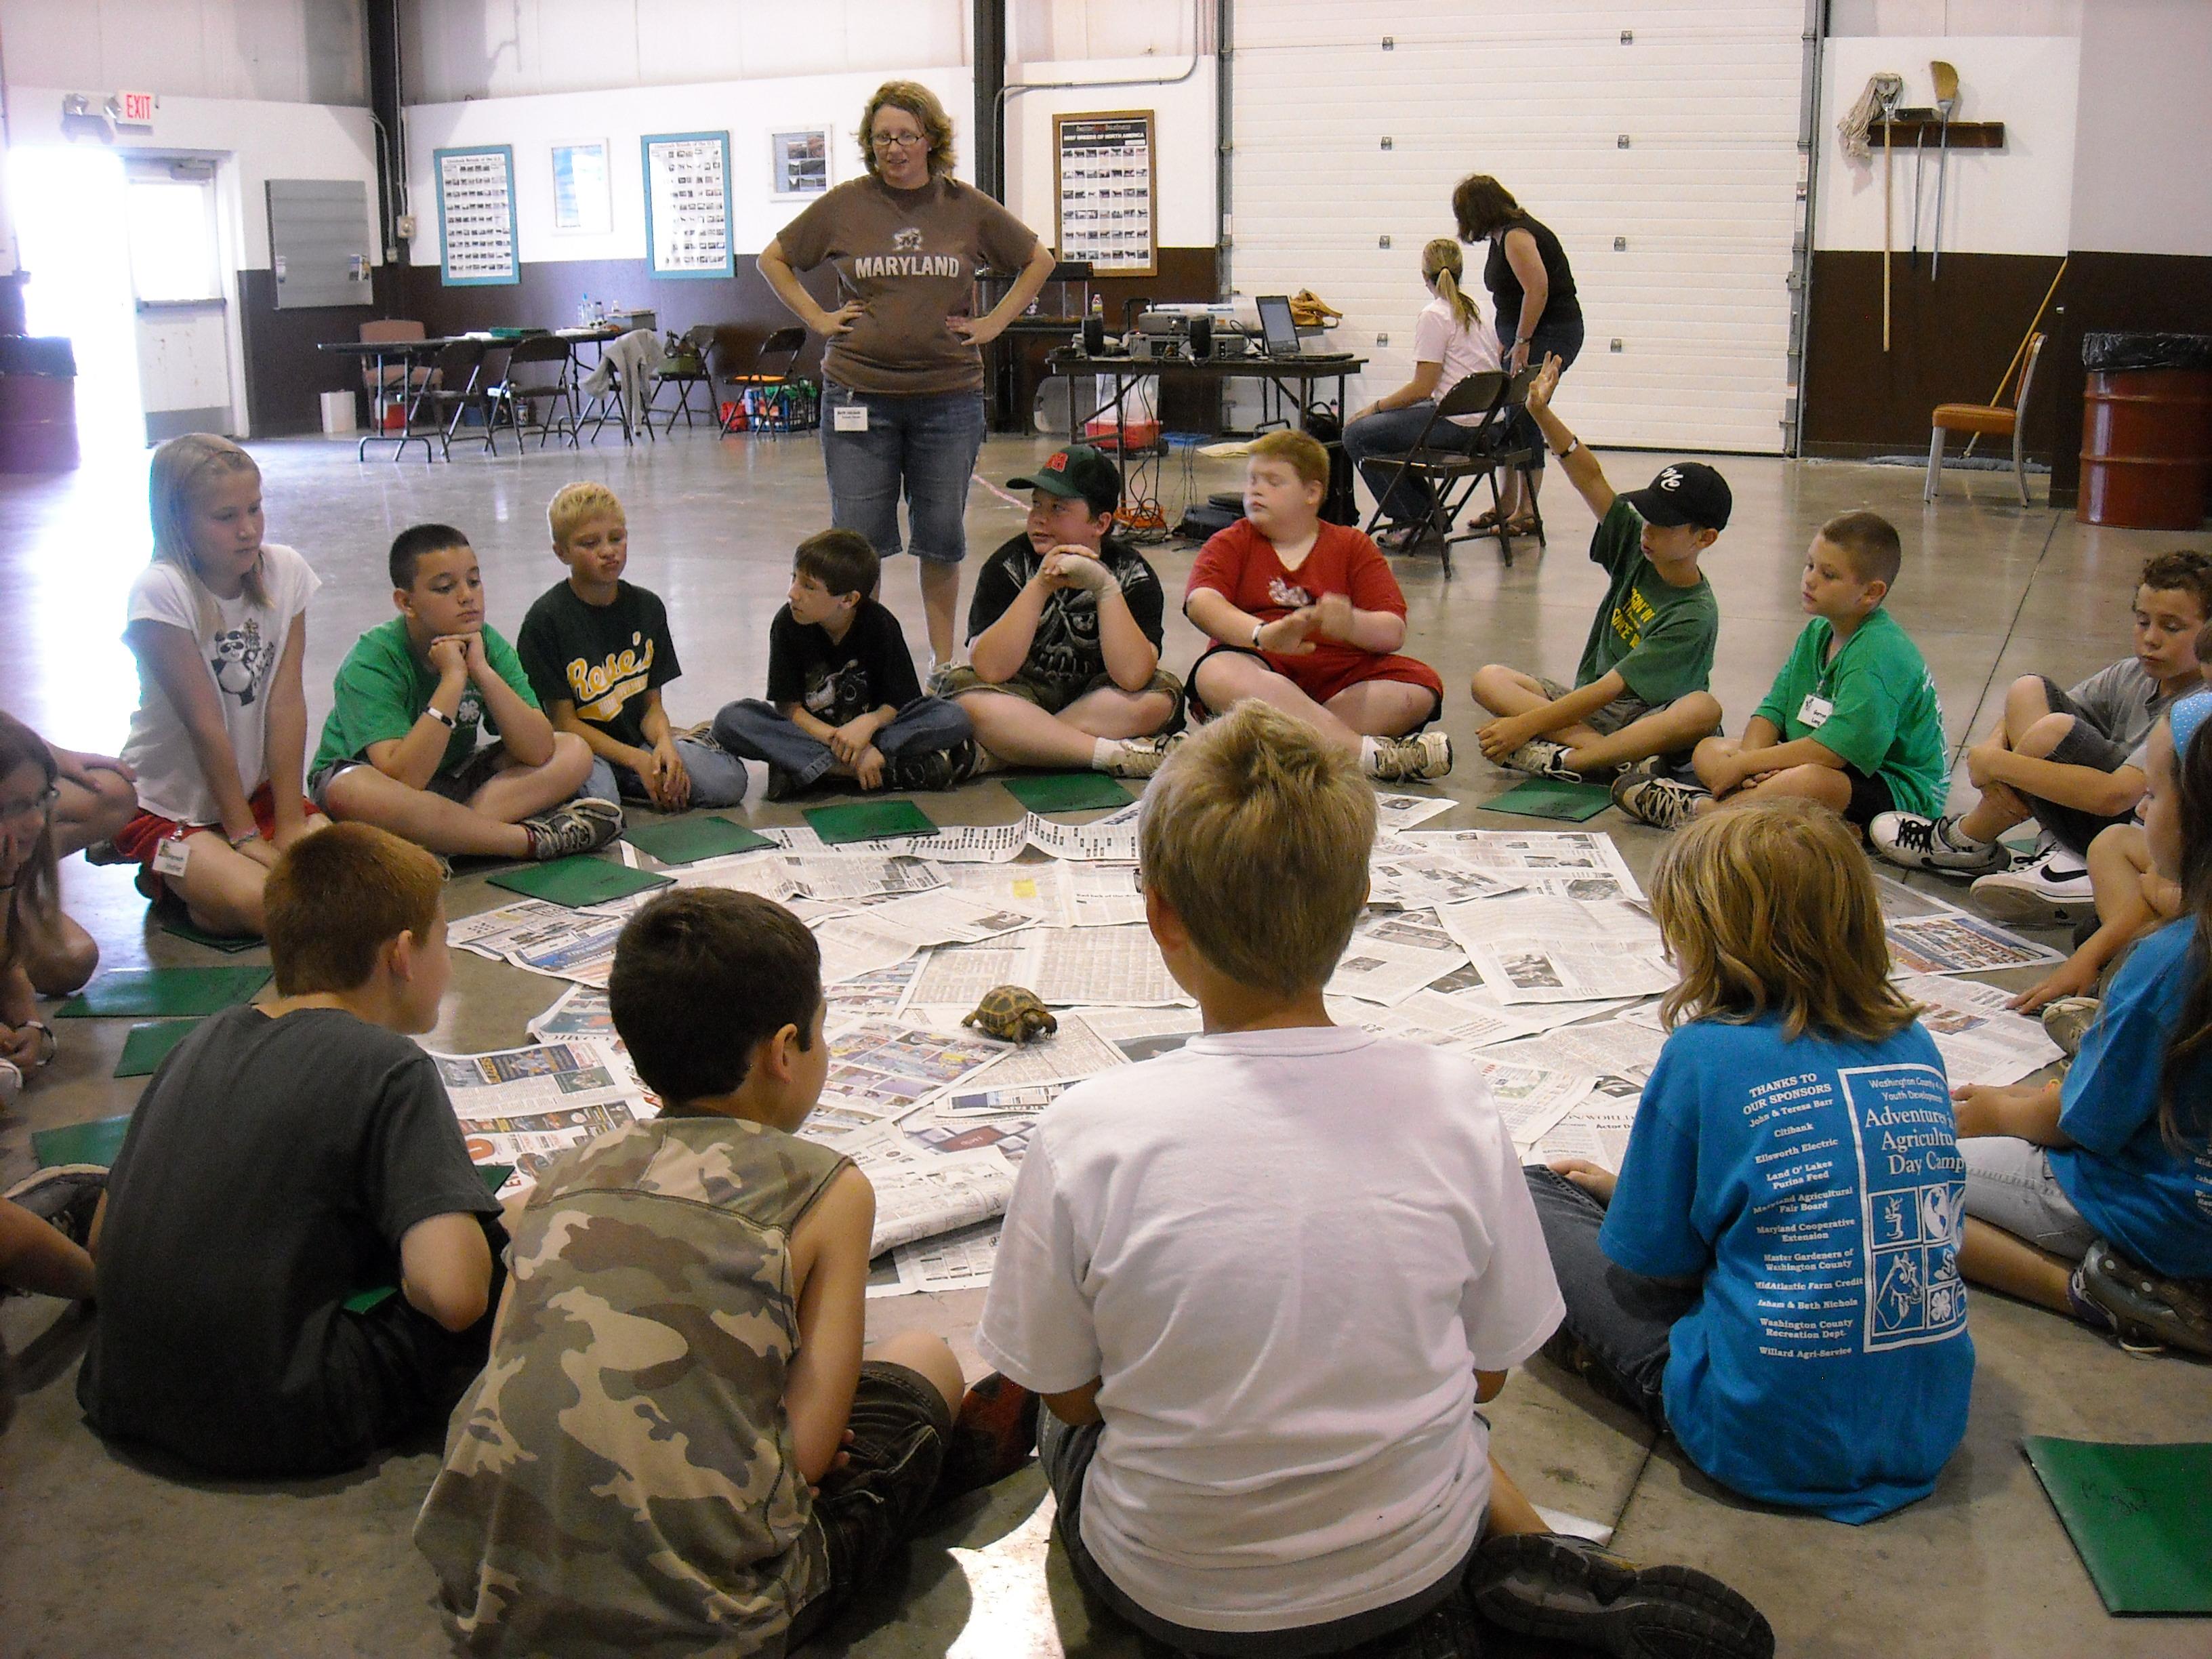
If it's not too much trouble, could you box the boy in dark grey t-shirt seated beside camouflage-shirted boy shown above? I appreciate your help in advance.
[77,825,497,1475]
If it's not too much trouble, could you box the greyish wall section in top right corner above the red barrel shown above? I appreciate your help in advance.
[2072,0,2212,257]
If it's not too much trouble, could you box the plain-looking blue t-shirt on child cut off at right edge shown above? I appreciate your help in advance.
[2051,920,2212,1279]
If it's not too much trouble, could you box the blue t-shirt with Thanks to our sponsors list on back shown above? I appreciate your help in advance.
[1599,1015,1973,1522]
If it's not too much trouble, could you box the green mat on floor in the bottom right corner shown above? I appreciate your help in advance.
[2020,1435,2212,1619]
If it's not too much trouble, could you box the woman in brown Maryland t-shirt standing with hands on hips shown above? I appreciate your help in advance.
[759,80,1055,668]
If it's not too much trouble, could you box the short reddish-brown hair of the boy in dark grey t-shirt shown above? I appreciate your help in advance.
[261,823,445,998]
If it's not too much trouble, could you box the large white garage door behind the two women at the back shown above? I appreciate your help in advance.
[1229,0,1805,453]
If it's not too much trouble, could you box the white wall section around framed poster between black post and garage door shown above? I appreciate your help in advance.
[1006,54,1218,248]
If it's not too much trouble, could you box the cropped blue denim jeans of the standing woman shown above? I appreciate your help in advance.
[823,380,984,564]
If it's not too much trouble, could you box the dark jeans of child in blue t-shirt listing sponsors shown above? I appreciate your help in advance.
[1526,1166,1703,1429]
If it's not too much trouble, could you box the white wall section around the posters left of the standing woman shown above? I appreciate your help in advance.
[407,64,986,270]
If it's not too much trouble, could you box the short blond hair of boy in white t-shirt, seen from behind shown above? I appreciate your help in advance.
[1137,701,1376,998]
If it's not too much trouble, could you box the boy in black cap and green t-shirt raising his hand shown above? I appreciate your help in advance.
[1473,359,1732,783]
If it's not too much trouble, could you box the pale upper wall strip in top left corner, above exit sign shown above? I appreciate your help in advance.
[0,0,369,104]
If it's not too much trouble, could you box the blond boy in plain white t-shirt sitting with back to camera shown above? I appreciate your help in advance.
[975,701,1771,1659]
